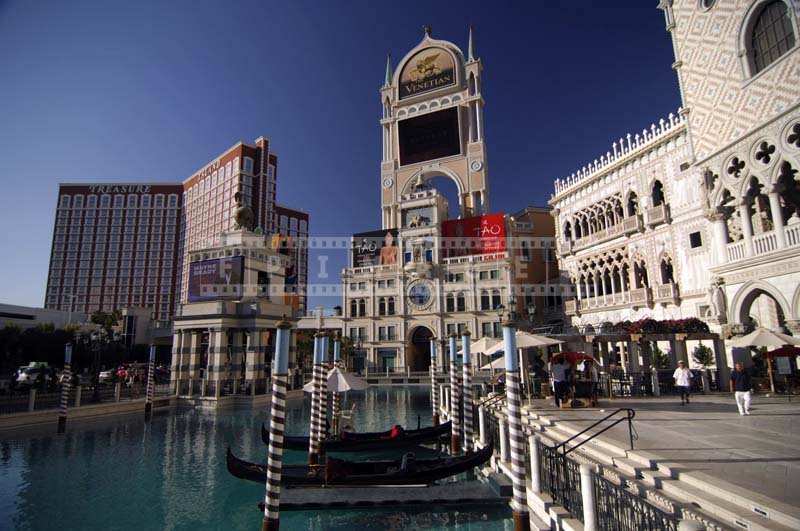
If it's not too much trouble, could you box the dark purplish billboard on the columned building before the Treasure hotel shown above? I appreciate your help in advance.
[188,256,244,302]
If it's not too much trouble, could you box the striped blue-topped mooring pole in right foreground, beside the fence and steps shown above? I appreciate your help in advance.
[502,319,530,531]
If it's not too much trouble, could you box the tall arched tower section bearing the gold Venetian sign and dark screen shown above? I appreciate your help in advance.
[380,26,488,229]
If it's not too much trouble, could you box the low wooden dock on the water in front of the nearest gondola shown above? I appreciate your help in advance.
[281,481,508,511]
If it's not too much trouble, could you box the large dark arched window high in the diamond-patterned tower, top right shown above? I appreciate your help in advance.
[747,0,795,75]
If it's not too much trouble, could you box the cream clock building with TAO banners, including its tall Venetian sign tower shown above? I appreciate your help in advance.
[300,28,563,371]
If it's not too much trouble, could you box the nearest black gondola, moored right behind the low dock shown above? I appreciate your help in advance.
[226,441,494,487]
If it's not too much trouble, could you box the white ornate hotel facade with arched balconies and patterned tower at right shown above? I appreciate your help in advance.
[550,0,800,360]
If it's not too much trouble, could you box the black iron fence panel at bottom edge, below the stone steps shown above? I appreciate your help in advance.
[593,474,678,531]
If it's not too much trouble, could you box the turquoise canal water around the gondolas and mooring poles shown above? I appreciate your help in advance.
[0,387,511,531]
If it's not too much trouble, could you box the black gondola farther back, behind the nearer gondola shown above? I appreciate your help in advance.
[261,421,450,452]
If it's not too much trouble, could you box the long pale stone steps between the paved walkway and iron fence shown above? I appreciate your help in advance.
[523,410,800,531]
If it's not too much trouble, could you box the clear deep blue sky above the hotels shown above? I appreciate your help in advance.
[0,0,680,306]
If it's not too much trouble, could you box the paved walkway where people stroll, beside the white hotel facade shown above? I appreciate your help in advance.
[536,395,800,507]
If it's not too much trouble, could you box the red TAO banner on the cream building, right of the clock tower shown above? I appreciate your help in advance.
[442,214,506,257]
